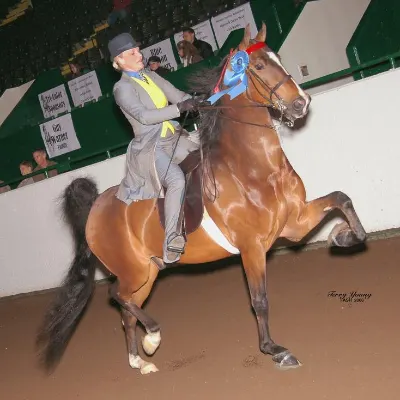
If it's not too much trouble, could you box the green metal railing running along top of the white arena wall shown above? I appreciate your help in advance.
[0,51,400,191]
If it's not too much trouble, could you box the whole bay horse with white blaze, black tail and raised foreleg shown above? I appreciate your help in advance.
[37,23,366,374]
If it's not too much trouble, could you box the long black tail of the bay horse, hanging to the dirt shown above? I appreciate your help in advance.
[36,178,98,370]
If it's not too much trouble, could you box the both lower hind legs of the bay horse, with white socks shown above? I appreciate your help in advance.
[110,268,161,374]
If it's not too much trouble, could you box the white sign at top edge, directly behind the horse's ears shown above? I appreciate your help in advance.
[211,3,258,47]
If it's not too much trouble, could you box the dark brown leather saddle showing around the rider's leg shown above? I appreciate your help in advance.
[157,150,204,236]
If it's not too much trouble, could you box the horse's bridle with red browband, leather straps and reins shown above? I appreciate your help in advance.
[198,42,293,130]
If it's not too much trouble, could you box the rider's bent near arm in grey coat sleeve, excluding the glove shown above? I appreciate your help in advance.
[114,84,180,125]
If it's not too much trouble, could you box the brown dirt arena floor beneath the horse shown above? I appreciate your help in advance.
[0,237,400,400]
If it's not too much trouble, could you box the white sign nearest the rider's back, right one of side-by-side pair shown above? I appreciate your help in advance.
[68,71,101,107]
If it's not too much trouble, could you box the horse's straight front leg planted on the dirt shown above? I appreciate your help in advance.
[241,244,301,369]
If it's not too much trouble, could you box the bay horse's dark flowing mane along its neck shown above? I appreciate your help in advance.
[187,56,228,198]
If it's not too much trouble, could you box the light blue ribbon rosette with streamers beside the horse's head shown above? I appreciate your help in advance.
[207,51,250,104]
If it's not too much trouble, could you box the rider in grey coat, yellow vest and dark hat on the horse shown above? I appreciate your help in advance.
[108,33,200,263]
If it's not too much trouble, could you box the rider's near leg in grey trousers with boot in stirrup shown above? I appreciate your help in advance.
[155,147,185,263]
